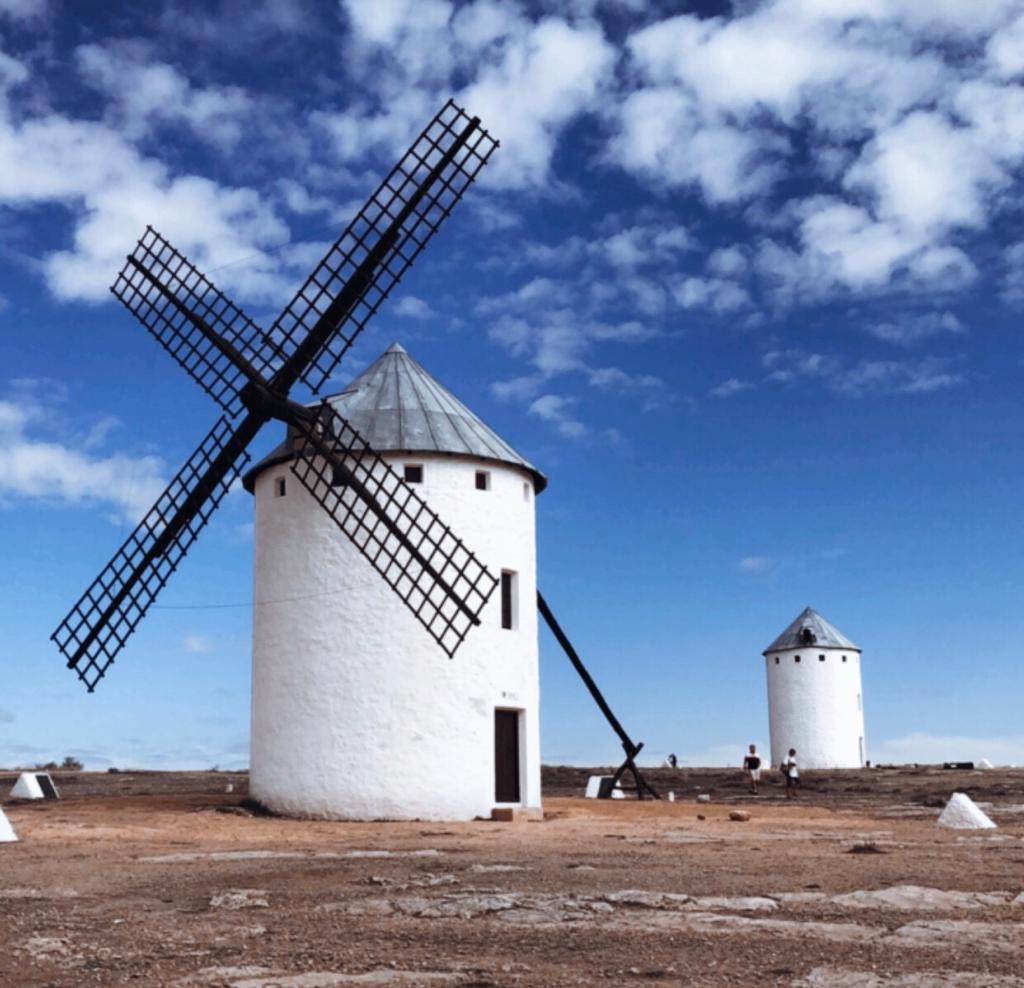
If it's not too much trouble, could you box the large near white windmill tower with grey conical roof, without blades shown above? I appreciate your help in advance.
[245,344,547,820]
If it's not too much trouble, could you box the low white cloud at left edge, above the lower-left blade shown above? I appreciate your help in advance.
[0,382,166,522]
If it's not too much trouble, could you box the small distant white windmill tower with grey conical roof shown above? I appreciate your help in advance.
[763,607,865,769]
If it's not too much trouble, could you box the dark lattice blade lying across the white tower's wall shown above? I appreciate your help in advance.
[291,402,498,656]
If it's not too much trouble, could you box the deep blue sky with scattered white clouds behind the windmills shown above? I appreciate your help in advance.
[0,0,1024,768]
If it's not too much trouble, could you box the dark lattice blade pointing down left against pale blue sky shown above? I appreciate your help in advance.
[50,416,264,693]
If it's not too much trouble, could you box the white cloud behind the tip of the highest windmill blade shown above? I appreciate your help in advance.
[313,0,614,188]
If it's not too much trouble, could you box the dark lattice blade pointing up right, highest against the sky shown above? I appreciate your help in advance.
[268,100,498,392]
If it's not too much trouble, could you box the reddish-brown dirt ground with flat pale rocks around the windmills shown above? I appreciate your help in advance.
[0,768,1024,988]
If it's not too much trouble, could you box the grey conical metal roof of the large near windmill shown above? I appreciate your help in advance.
[243,343,548,493]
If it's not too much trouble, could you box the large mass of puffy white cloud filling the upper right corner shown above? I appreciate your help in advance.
[607,0,1024,305]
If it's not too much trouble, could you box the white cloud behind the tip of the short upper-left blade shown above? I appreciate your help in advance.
[0,51,289,301]
